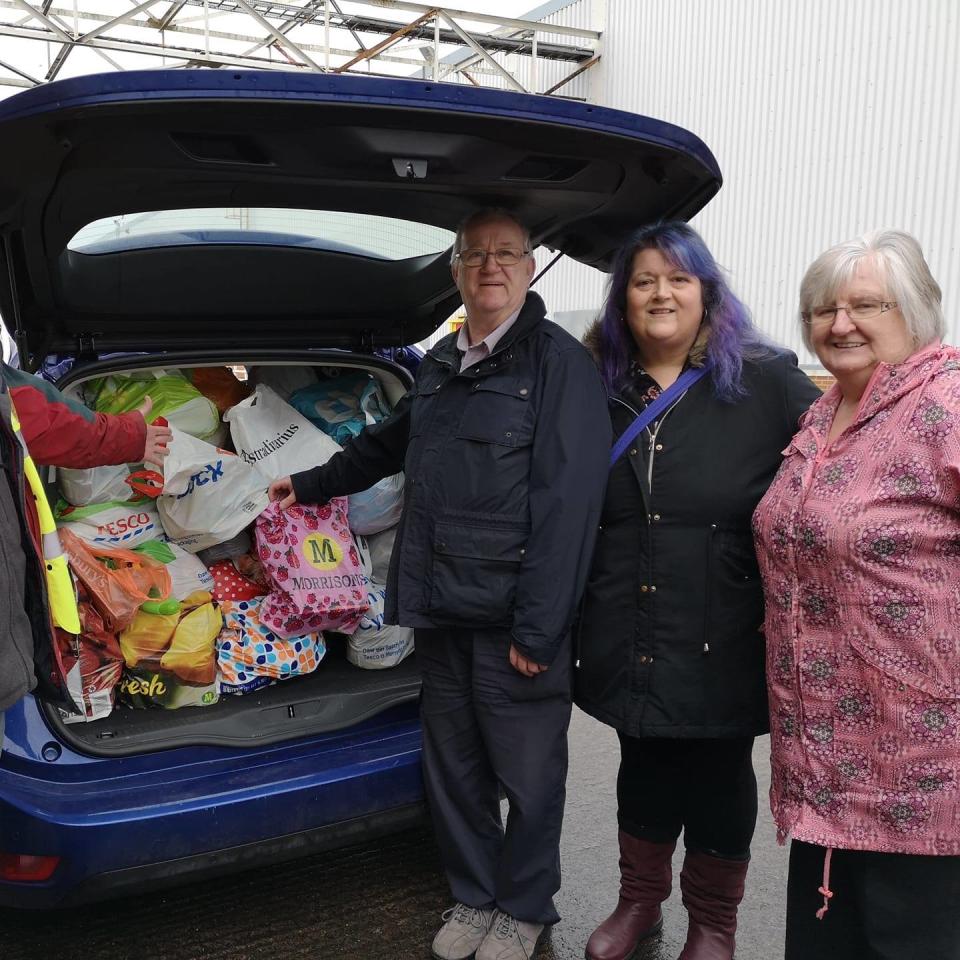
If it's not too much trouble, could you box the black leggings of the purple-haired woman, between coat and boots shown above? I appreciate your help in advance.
[617,733,757,860]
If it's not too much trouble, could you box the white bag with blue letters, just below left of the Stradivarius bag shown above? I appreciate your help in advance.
[157,430,268,553]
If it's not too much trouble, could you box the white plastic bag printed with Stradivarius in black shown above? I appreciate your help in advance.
[223,384,340,480]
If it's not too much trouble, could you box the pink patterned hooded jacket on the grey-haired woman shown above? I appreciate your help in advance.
[753,344,960,855]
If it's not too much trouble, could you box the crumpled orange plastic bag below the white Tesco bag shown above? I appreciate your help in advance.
[58,528,173,633]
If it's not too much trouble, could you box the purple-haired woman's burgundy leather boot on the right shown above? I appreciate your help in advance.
[679,850,749,960]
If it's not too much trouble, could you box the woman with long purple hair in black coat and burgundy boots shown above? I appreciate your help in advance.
[576,223,819,960]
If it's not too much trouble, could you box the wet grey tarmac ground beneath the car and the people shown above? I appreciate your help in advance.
[0,710,787,960]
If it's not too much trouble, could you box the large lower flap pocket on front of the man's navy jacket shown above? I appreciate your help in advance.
[428,520,528,626]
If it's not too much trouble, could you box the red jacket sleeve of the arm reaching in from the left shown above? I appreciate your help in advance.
[10,386,147,469]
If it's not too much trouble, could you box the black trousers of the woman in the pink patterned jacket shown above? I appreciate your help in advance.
[786,840,960,960]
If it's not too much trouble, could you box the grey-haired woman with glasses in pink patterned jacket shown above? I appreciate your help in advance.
[753,231,960,960]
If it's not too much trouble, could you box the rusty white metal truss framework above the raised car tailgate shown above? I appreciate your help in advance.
[0,0,601,96]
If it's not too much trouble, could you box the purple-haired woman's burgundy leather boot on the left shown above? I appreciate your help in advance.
[586,830,677,960]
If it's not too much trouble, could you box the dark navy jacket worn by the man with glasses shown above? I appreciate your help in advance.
[293,293,610,664]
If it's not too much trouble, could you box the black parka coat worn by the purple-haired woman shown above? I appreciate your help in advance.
[575,342,820,737]
